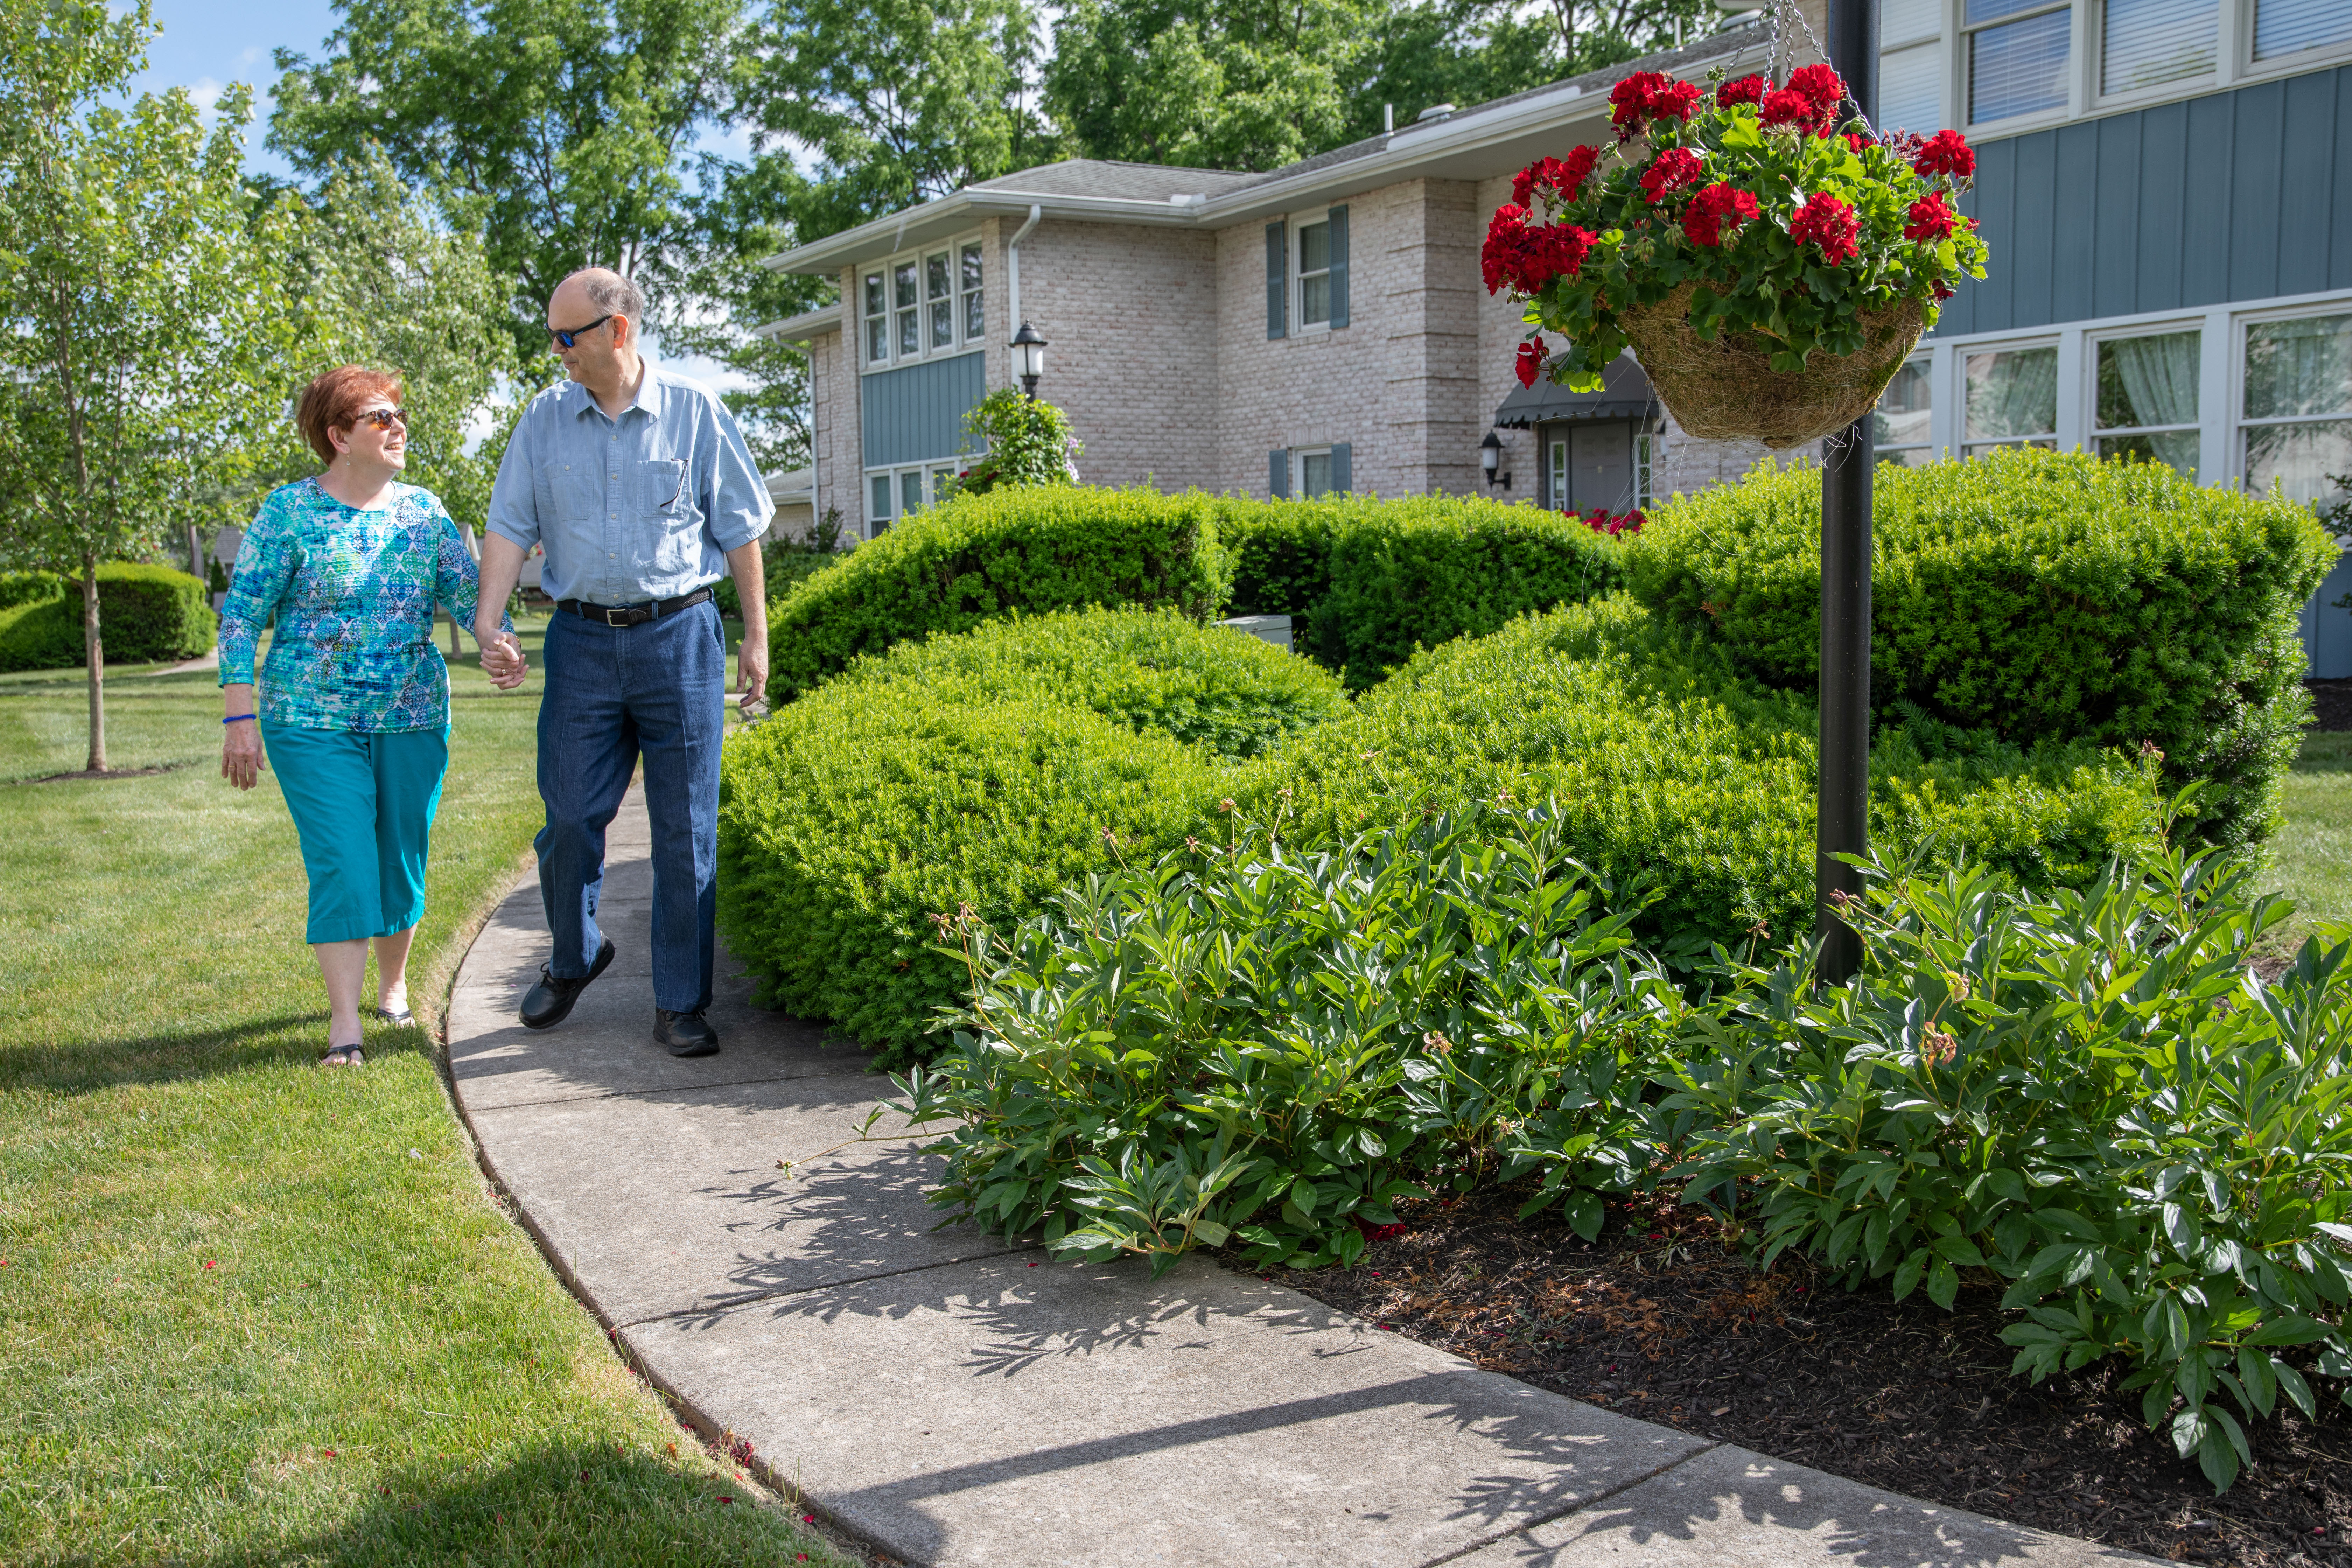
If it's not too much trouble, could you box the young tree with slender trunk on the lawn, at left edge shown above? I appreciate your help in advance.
[0,0,303,771]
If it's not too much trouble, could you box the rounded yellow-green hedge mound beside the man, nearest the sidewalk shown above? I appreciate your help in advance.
[720,606,1345,1060]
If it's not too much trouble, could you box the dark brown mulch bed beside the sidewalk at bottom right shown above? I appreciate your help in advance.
[1270,1190,2352,1568]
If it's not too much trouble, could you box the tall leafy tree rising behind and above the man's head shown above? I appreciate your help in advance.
[271,0,743,350]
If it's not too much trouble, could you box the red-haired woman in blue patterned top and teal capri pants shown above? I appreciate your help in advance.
[221,364,522,1067]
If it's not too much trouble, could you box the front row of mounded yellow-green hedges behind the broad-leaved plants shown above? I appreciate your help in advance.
[720,595,2157,1065]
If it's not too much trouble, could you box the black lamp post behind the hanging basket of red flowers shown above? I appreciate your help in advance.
[1813,0,1879,985]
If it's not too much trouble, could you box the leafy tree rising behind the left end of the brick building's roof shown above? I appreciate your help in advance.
[741,0,1058,242]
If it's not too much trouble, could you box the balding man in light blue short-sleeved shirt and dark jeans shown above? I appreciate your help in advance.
[475,268,774,1056]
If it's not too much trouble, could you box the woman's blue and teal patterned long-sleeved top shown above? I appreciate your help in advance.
[221,479,510,731]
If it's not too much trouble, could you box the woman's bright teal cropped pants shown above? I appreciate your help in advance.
[261,719,449,943]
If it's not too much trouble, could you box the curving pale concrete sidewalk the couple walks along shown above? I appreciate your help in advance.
[449,792,2152,1568]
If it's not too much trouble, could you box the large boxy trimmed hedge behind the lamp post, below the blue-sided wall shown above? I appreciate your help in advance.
[1623,449,2336,846]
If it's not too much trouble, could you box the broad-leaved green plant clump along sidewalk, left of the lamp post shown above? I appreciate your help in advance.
[901,806,1684,1274]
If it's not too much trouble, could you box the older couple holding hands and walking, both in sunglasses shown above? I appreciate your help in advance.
[221,268,771,1067]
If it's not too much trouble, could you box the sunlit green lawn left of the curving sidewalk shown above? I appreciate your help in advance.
[0,623,844,1566]
